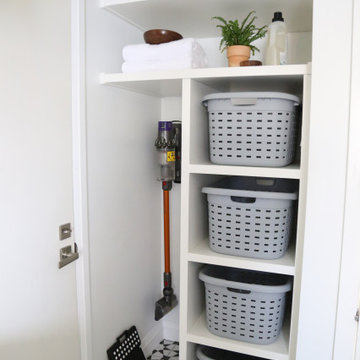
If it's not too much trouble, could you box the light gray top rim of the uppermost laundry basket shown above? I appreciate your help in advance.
[202,91,300,106]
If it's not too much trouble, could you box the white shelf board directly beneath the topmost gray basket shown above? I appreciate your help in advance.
[184,163,301,179]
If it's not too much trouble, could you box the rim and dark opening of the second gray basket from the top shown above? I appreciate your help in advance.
[202,176,298,200]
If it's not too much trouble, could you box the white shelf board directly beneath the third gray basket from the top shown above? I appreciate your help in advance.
[186,312,289,360]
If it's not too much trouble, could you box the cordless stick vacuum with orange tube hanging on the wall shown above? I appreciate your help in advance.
[155,121,181,321]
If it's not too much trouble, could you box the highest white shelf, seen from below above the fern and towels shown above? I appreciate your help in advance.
[100,0,312,38]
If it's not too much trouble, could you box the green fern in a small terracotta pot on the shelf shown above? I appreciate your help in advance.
[212,11,267,66]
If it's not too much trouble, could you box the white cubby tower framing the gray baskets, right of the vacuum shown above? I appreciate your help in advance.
[180,65,310,360]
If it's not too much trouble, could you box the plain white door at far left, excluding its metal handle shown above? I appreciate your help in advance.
[0,0,80,360]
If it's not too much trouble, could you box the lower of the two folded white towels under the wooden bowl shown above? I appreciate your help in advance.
[122,57,207,73]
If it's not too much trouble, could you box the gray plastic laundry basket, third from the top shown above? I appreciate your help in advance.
[199,265,292,344]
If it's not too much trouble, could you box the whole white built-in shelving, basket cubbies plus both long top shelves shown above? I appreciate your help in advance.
[100,0,312,360]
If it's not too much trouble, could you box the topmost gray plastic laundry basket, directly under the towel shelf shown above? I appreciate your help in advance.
[203,92,299,167]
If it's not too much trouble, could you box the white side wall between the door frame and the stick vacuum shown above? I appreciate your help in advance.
[86,0,163,360]
